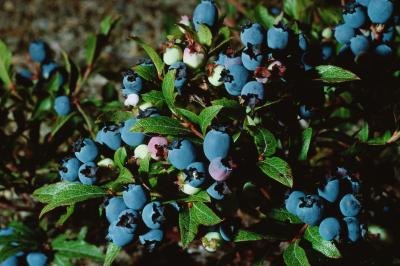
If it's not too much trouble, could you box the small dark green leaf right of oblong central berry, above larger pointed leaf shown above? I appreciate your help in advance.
[252,127,277,157]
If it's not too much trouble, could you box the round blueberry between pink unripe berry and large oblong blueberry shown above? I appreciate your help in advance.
[168,139,196,170]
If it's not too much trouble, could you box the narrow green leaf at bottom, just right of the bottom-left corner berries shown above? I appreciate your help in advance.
[52,239,104,261]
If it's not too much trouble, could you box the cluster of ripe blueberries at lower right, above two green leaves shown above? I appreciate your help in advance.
[285,168,365,242]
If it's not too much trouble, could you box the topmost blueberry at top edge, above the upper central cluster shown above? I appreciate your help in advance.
[193,0,218,31]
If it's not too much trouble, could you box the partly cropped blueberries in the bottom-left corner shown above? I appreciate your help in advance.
[0,228,48,266]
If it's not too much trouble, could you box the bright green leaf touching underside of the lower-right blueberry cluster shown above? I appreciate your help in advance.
[304,226,342,259]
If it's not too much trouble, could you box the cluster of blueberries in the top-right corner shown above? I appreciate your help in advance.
[335,0,399,57]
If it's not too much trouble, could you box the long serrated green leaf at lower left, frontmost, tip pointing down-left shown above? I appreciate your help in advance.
[40,183,106,216]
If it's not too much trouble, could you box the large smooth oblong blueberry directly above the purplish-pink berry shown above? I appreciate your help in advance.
[203,129,232,161]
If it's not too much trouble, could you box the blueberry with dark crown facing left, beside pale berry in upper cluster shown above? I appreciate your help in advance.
[221,65,250,96]
